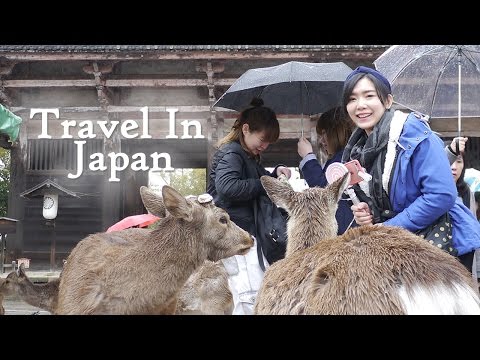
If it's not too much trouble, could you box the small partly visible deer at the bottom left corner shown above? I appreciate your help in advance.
[2,264,60,313]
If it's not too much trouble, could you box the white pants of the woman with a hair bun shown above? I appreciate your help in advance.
[222,240,268,315]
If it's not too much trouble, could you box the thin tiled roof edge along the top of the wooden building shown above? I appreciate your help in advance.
[0,45,388,53]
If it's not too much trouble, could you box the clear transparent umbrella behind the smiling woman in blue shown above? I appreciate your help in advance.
[374,45,480,136]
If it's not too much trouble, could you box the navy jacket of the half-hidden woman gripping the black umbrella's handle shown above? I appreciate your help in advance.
[299,149,358,235]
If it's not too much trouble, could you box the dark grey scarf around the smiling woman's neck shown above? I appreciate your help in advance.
[342,110,396,223]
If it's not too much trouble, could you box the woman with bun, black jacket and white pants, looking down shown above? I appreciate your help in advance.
[207,98,291,315]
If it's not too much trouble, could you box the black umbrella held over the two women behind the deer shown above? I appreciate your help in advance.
[213,61,352,135]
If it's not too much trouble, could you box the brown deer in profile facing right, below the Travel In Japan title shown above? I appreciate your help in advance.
[55,186,253,314]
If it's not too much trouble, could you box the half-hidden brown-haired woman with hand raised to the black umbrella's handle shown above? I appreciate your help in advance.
[297,107,356,235]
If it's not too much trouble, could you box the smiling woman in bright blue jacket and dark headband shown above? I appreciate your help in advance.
[342,66,480,271]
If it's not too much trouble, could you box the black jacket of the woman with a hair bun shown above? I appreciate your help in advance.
[207,142,280,234]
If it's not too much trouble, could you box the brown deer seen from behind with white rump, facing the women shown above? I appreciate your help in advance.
[255,174,480,315]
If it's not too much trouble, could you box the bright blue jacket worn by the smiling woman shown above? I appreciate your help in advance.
[384,113,480,255]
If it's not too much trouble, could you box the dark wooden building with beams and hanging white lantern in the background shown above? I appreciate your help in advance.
[0,45,480,263]
